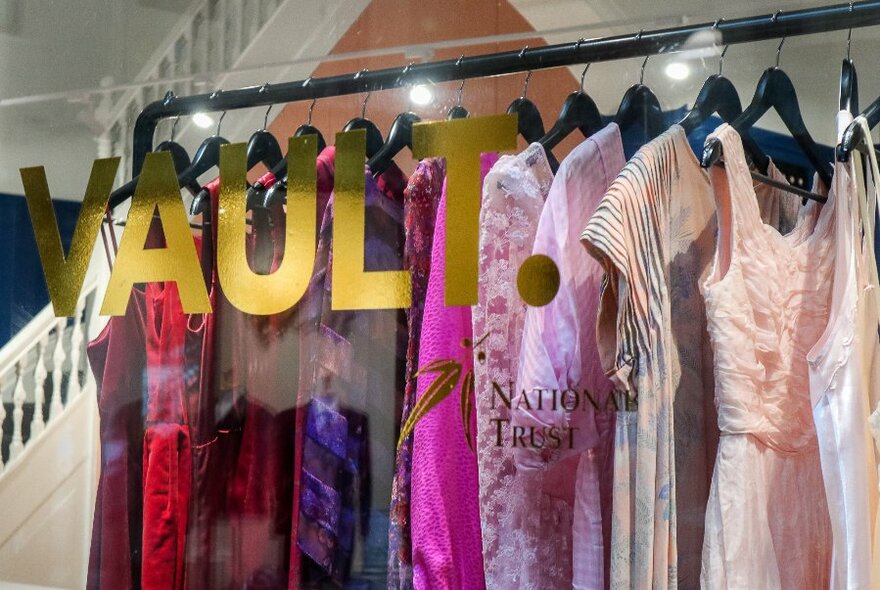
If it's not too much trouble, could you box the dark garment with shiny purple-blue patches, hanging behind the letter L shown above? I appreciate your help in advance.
[291,155,407,587]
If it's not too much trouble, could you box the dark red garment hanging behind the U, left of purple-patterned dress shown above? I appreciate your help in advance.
[223,178,299,588]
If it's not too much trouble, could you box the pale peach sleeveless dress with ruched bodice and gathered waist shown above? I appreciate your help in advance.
[701,125,837,588]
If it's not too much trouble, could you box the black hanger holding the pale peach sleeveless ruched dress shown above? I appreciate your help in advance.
[702,38,832,188]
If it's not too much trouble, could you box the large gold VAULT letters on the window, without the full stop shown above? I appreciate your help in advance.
[21,115,517,317]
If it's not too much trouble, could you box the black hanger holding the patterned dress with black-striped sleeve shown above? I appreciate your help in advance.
[678,46,770,174]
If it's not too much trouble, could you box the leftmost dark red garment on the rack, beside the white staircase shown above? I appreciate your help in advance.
[86,290,146,590]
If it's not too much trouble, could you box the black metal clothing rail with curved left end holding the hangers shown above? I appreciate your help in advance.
[120,0,880,207]
